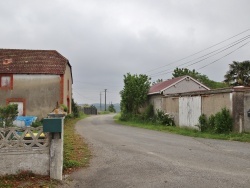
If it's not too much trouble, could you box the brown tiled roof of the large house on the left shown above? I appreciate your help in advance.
[0,49,70,74]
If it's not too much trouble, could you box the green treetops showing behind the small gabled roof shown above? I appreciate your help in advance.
[172,67,228,89]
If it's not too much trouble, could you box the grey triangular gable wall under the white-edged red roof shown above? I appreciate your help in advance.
[163,79,206,95]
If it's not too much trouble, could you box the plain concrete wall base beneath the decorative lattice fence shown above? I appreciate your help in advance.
[0,148,50,175]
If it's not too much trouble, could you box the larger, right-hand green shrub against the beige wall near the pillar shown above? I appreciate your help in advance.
[214,108,233,133]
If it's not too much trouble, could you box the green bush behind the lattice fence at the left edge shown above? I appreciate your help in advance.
[0,104,18,127]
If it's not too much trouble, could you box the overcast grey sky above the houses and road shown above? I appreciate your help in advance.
[0,0,250,104]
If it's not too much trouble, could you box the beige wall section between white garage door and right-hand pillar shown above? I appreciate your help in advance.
[201,93,232,117]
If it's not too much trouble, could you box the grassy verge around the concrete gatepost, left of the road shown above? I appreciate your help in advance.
[0,115,91,188]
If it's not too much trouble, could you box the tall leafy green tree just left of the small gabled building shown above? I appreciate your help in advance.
[120,73,150,115]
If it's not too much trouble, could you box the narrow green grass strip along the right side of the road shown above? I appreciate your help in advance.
[114,114,250,142]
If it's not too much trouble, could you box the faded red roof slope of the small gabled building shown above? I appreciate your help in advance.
[148,76,186,94]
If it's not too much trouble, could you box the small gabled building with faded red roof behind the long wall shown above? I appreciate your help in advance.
[148,76,210,110]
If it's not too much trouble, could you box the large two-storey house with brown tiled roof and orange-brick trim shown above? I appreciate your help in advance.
[0,49,73,118]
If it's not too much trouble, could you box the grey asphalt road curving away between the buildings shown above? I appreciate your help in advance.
[62,115,250,188]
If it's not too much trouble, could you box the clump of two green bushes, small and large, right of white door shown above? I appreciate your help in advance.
[197,108,233,134]
